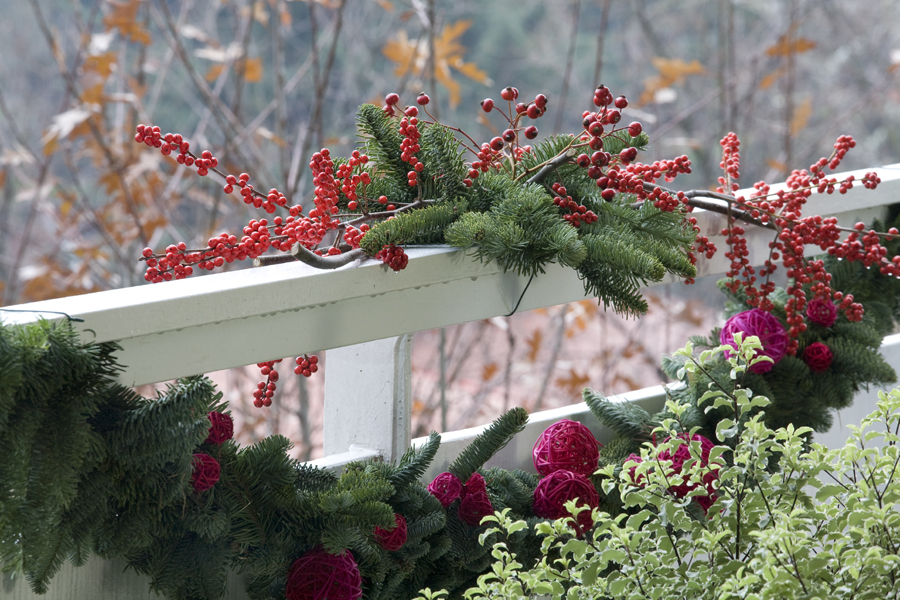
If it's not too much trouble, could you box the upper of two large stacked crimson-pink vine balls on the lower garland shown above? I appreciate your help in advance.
[532,419,600,476]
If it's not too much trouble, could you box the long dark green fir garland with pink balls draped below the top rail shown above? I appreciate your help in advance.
[0,236,900,600]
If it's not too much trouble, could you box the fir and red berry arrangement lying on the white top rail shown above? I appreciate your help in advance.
[135,85,900,407]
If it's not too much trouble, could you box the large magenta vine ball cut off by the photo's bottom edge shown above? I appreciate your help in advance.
[284,548,362,600]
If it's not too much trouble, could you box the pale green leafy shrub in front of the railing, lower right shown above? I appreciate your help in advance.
[464,338,900,599]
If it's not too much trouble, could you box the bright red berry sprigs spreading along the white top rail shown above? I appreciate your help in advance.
[135,85,900,406]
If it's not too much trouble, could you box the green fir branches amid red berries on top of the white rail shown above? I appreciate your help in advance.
[342,105,696,315]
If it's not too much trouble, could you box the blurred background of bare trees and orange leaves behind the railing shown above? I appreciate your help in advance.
[0,0,900,456]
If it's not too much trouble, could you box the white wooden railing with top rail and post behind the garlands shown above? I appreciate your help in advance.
[0,164,900,600]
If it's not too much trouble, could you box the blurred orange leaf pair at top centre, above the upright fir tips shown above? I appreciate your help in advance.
[381,21,491,107]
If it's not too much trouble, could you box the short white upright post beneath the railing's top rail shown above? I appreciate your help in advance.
[323,334,412,461]
